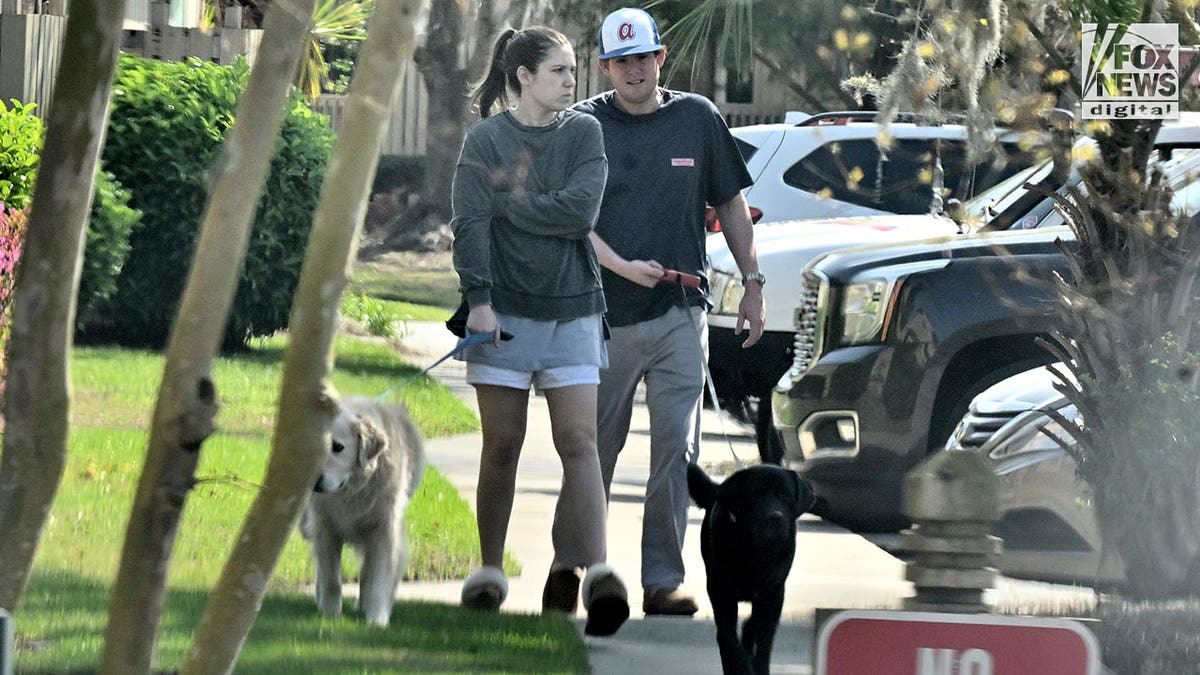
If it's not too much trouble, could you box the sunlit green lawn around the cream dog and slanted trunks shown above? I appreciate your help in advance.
[9,338,587,673]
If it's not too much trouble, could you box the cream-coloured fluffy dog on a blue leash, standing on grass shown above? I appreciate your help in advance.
[300,396,425,626]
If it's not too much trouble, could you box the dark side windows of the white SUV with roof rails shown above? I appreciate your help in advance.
[784,138,1028,214]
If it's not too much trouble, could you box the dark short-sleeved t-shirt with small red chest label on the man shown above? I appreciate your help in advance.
[575,90,751,325]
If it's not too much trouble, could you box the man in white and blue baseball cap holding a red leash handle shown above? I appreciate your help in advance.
[566,8,764,616]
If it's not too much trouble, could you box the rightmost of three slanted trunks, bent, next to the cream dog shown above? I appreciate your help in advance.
[182,0,432,675]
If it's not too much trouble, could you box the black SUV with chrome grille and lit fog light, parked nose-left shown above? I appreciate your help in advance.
[773,125,1200,530]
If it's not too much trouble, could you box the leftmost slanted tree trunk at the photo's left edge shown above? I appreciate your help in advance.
[0,0,125,611]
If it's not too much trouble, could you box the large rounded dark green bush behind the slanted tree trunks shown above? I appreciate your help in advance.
[89,55,332,347]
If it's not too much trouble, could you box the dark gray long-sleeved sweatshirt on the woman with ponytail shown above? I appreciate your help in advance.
[450,110,608,321]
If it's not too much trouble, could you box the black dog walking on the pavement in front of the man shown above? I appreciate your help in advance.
[688,464,816,675]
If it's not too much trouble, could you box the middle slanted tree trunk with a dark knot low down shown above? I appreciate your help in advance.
[101,0,316,675]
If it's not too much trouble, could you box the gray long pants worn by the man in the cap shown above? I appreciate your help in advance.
[596,307,708,590]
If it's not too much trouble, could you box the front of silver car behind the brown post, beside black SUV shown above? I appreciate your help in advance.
[946,368,1124,586]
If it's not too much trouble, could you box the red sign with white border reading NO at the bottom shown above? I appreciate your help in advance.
[815,609,1100,675]
